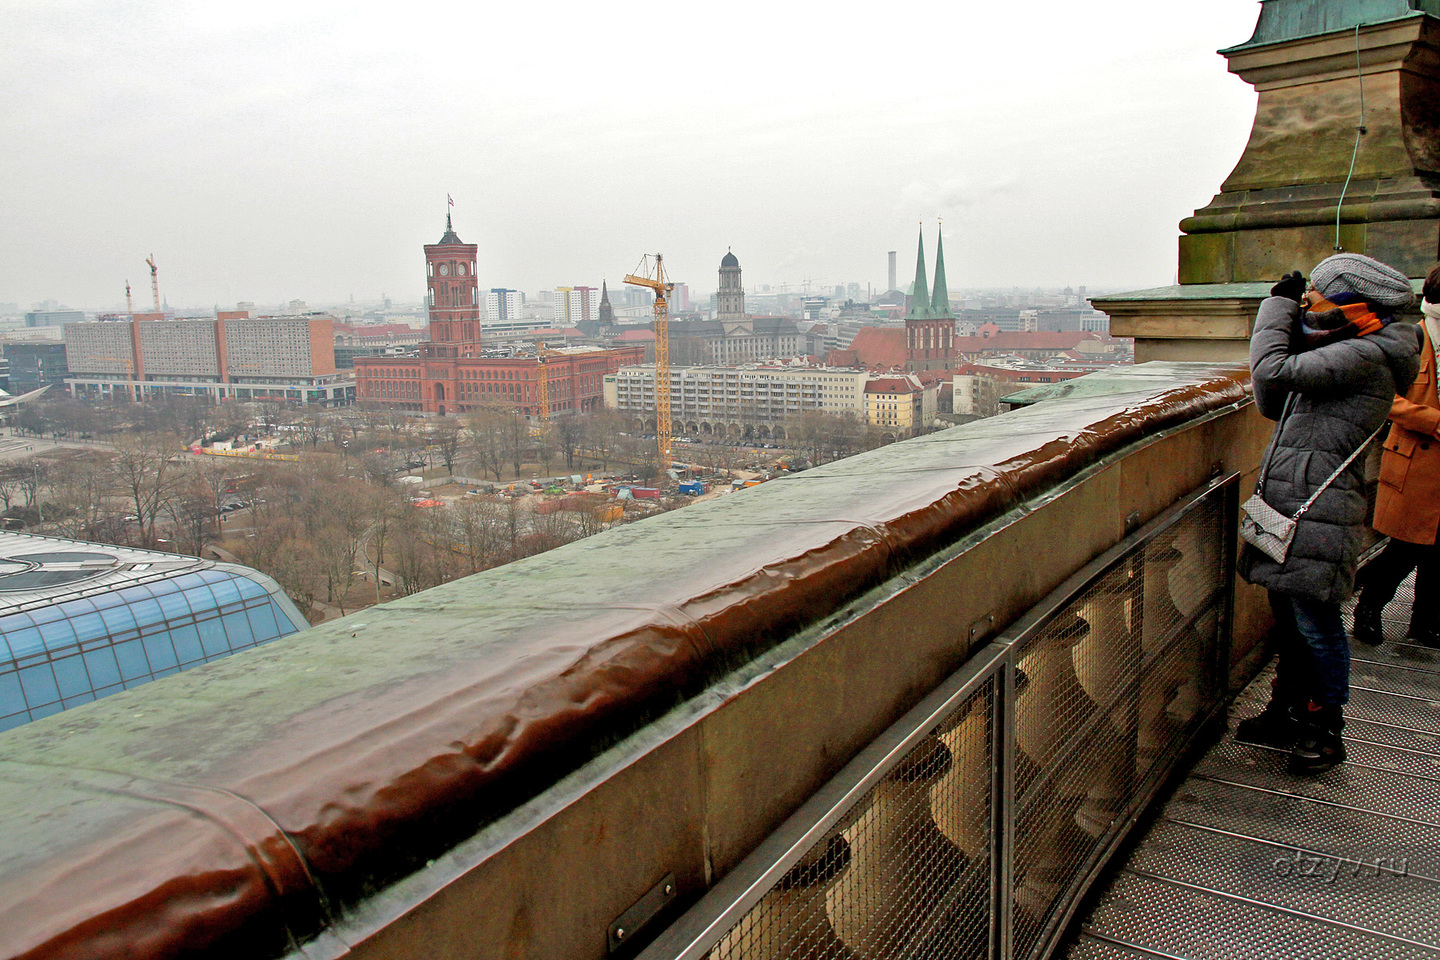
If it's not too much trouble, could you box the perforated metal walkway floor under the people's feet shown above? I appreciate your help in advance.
[1068,583,1440,960]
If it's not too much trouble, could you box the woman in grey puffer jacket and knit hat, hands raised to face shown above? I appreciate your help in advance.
[1236,253,1420,773]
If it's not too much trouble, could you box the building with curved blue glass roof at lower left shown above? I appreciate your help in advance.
[0,531,307,730]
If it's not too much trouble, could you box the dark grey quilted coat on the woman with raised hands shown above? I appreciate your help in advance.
[1240,296,1420,603]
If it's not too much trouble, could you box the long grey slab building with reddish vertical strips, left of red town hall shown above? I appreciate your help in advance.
[65,311,354,404]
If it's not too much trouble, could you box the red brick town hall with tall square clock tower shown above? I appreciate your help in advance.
[356,216,645,416]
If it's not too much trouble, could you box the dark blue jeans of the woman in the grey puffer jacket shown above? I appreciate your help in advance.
[1270,590,1349,707]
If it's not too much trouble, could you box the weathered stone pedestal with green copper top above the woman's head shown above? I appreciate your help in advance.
[1179,0,1440,284]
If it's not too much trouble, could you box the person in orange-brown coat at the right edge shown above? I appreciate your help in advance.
[1355,263,1440,646]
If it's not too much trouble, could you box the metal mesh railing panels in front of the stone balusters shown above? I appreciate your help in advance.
[642,478,1237,960]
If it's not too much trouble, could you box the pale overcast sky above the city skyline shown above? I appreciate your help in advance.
[0,0,1260,308]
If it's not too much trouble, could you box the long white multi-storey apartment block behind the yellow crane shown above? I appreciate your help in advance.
[603,366,870,438]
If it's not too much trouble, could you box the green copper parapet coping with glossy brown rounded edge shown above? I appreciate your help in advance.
[0,364,1248,960]
